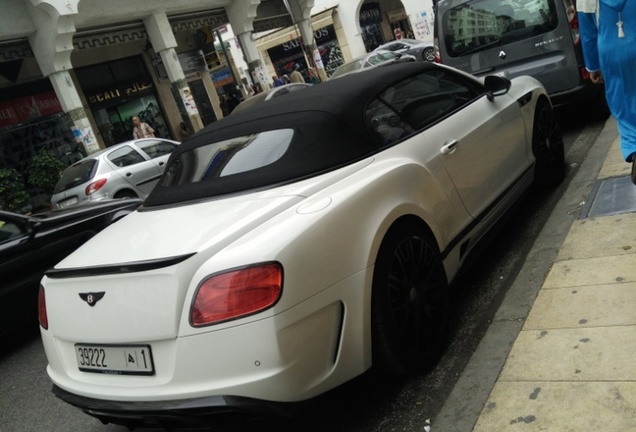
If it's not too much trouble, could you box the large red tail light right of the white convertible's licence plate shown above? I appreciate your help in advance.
[190,262,283,327]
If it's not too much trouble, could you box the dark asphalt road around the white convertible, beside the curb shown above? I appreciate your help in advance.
[0,110,604,432]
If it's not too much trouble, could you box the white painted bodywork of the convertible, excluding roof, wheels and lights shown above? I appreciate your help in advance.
[41,66,560,422]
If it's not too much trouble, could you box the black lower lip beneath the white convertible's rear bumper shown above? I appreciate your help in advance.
[52,385,306,430]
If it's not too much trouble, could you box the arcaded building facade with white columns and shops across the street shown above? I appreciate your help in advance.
[0,0,433,208]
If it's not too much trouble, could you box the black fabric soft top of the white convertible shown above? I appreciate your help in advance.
[144,62,437,207]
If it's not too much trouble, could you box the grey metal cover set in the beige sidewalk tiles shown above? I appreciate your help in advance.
[579,176,636,219]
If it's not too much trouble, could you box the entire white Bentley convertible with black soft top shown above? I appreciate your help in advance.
[39,62,565,428]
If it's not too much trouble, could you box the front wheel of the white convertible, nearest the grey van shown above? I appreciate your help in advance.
[532,99,565,189]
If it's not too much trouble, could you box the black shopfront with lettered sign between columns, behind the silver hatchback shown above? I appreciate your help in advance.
[75,56,174,147]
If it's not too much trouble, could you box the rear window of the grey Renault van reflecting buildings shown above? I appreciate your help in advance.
[442,0,558,57]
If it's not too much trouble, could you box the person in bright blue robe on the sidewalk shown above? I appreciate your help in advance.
[576,0,636,184]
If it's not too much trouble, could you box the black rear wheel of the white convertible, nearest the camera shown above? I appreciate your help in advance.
[371,224,450,375]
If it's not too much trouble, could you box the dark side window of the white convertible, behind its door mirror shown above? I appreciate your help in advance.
[366,69,484,145]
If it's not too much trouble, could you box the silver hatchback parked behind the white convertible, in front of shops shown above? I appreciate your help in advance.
[51,138,179,209]
